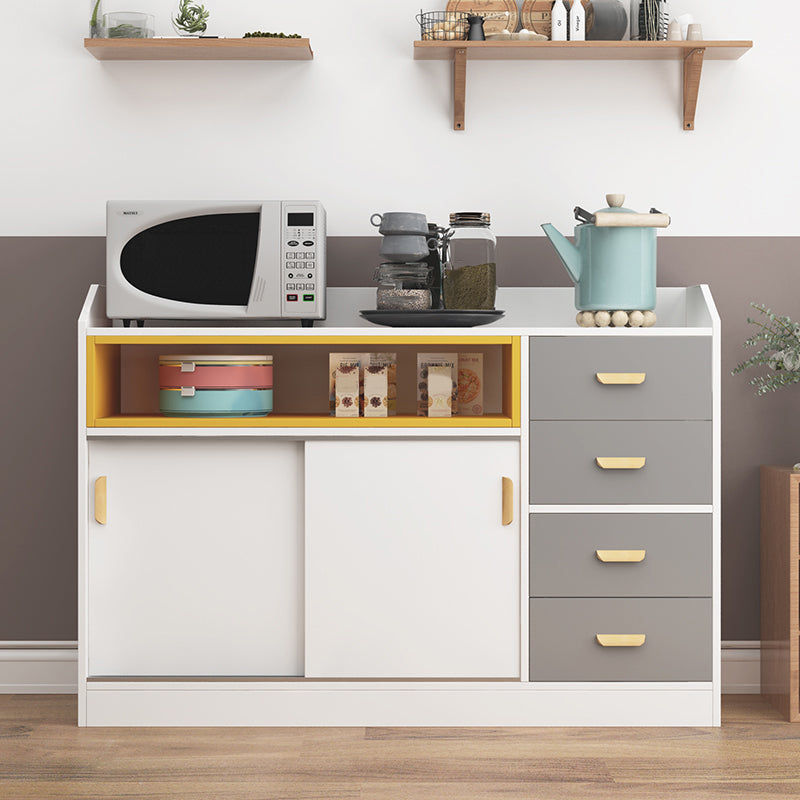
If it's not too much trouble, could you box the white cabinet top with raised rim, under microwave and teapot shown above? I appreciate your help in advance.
[80,285,719,340]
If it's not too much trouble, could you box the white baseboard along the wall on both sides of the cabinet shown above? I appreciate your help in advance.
[0,641,761,694]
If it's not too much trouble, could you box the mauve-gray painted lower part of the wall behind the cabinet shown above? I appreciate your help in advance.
[0,237,800,641]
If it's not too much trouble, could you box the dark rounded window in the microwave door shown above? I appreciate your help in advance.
[120,212,260,306]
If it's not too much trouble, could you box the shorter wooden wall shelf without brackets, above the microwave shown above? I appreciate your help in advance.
[83,37,314,61]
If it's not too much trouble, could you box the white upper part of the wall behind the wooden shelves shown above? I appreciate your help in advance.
[0,0,800,236]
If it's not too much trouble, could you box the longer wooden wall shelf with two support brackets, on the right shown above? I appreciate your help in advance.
[414,41,753,131]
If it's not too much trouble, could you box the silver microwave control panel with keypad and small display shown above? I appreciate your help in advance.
[281,203,326,319]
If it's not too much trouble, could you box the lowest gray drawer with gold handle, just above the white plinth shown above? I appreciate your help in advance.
[530,598,711,681]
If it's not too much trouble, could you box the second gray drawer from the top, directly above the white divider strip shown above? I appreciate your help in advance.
[530,421,711,504]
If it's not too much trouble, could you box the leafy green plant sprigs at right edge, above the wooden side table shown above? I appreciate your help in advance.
[732,303,800,395]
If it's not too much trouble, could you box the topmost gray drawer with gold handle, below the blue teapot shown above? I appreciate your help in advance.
[530,336,711,420]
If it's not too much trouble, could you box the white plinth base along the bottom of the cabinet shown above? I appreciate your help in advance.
[80,681,720,727]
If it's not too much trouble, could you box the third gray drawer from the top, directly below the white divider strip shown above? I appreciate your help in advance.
[530,514,712,597]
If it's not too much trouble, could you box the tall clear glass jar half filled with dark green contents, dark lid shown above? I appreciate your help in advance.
[442,211,497,310]
